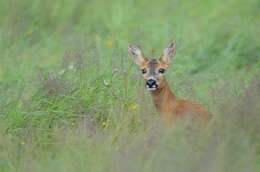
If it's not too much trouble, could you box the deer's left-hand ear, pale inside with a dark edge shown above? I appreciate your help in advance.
[128,44,147,66]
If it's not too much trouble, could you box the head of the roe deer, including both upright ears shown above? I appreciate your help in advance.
[128,43,175,91]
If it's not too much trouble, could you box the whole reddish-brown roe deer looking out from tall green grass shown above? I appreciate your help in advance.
[128,43,209,122]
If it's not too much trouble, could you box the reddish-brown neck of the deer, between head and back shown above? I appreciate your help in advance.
[151,79,177,112]
